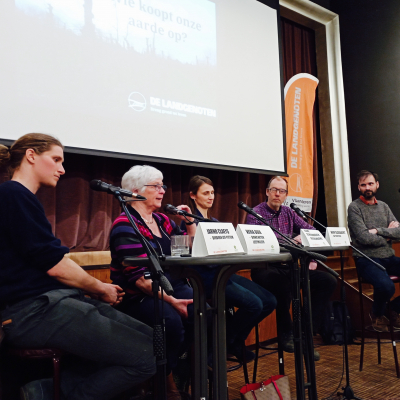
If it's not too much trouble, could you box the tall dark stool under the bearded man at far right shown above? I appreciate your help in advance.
[357,272,400,378]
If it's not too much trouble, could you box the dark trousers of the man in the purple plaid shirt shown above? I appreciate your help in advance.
[251,265,336,336]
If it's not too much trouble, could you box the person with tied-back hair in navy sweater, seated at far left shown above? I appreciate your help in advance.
[0,133,155,400]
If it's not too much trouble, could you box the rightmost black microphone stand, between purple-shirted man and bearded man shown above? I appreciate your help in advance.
[295,210,364,400]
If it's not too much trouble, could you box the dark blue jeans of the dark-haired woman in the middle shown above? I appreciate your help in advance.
[193,266,276,345]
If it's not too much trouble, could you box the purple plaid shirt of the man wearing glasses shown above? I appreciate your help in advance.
[246,202,315,243]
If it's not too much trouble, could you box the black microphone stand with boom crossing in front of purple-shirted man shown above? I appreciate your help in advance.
[238,203,332,400]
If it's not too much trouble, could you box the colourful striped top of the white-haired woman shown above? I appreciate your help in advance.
[110,206,186,300]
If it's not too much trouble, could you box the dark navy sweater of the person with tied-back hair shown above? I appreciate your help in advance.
[0,181,69,307]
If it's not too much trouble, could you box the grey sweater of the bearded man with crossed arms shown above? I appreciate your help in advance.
[348,199,400,258]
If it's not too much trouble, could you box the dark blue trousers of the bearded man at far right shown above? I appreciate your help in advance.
[355,256,400,317]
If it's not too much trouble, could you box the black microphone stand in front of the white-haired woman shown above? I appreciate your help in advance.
[113,190,174,400]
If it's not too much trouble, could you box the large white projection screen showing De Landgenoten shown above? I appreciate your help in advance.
[0,0,286,173]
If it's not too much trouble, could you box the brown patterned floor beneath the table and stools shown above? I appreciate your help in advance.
[228,338,400,400]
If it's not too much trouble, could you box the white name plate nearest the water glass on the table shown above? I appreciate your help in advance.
[192,222,244,257]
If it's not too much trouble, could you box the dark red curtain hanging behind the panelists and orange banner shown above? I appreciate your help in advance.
[0,19,317,251]
